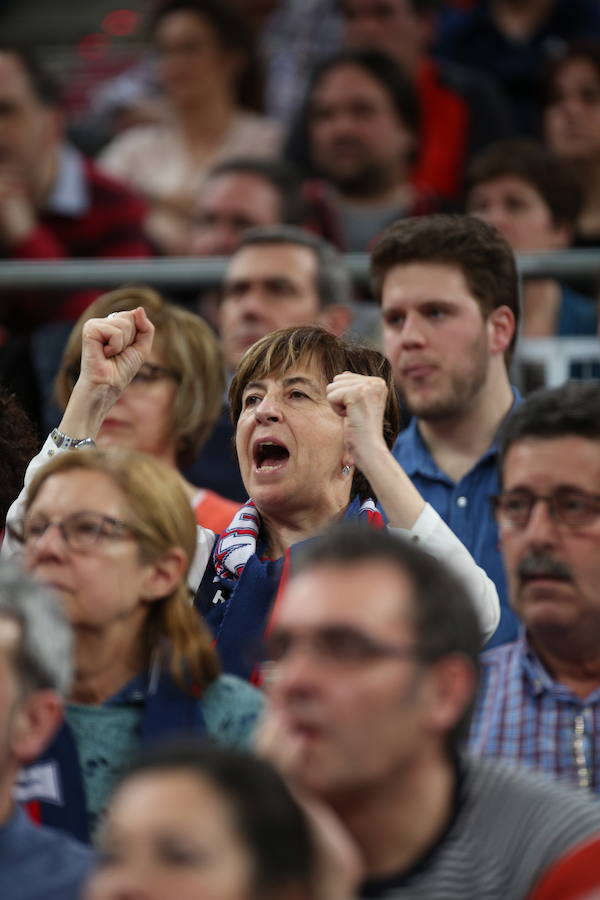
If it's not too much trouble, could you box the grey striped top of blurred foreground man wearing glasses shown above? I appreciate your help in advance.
[361,759,600,900]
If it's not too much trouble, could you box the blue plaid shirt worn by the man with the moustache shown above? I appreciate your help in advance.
[469,631,600,792]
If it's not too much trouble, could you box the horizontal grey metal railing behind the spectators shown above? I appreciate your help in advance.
[0,248,600,291]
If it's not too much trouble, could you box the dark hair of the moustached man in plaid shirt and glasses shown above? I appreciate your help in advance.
[498,381,600,473]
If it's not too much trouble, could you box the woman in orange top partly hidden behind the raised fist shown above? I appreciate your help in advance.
[55,287,239,533]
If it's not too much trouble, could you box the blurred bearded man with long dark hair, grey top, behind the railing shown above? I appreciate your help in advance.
[307,50,436,251]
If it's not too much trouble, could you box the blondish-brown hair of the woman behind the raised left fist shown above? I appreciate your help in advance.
[54,285,225,467]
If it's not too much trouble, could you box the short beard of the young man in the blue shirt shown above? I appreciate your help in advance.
[400,331,489,422]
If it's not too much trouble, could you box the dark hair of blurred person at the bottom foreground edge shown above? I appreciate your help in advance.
[117,739,317,900]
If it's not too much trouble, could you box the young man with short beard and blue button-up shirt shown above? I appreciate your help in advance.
[372,215,519,644]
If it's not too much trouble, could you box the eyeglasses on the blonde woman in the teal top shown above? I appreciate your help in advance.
[6,512,141,553]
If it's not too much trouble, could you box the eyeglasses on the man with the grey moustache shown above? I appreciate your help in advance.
[490,487,600,528]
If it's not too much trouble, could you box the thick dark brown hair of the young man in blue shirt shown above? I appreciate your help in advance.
[371,213,519,364]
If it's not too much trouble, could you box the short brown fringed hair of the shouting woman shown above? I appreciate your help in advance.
[229,325,400,500]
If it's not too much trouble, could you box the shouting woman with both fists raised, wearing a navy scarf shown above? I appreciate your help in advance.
[8,308,499,678]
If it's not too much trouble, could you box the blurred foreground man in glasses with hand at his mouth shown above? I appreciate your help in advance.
[263,528,600,900]
